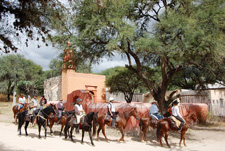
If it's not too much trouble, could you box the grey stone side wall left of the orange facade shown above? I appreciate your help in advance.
[44,76,62,101]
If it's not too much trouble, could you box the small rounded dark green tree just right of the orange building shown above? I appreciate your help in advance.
[105,67,147,103]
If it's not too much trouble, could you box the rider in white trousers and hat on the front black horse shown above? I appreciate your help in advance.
[74,98,85,123]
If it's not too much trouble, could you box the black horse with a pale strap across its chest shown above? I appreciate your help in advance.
[37,104,56,138]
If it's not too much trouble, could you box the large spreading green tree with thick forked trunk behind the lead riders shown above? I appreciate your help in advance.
[51,0,225,111]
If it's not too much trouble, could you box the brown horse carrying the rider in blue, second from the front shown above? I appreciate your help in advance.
[139,116,158,142]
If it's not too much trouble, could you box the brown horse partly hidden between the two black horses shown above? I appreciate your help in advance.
[48,110,75,136]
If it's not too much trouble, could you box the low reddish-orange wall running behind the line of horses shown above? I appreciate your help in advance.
[85,102,208,132]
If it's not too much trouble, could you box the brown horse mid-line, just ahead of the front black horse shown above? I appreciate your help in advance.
[97,108,137,142]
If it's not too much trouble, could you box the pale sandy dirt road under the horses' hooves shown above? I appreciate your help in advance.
[0,122,225,151]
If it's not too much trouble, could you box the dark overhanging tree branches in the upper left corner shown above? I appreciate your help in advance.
[0,0,66,53]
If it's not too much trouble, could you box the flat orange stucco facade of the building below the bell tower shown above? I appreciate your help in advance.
[62,69,106,103]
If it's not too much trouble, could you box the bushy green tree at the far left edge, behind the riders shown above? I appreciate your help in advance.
[0,55,43,101]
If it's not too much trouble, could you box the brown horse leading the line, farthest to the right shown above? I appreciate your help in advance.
[156,112,198,148]
